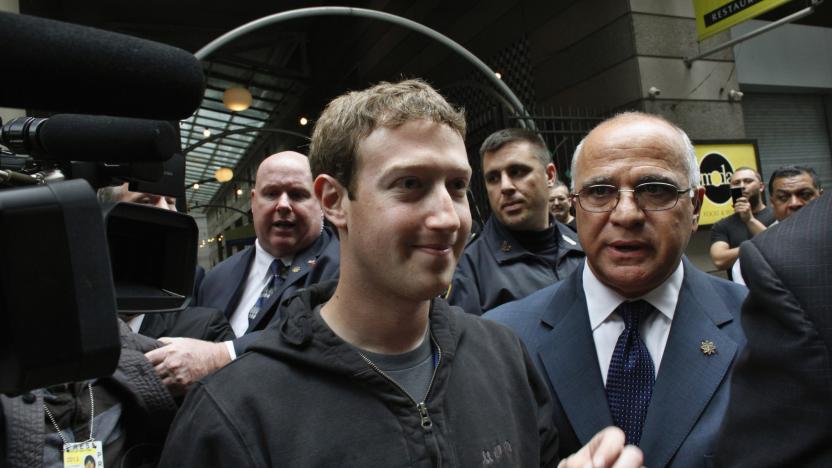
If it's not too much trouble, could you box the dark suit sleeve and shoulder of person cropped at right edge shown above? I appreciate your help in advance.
[716,194,832,467]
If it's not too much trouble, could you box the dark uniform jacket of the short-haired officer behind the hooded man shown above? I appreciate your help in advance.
[447,216,585,315]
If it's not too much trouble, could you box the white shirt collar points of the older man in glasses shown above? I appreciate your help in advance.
[583,260,685,330]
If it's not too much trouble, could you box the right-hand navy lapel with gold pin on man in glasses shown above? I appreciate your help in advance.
[639,261,738,466]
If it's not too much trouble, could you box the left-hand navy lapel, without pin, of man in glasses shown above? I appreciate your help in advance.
[537,268,612,444]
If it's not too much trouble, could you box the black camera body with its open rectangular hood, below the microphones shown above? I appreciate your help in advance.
[0,152,199,394]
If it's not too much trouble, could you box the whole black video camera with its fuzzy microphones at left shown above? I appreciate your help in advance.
[0,13,205,394]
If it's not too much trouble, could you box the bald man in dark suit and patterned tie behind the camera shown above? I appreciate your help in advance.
[147,151,339,394]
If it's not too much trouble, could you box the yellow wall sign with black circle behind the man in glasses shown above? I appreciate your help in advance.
[694,141,760,226]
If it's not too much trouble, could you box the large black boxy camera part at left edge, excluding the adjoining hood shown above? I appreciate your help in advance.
[0,180,120,393]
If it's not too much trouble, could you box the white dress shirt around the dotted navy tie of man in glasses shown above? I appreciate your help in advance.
[583,261,685,386]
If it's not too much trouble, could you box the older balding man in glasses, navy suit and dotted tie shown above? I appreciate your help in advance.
[485,112,745,467]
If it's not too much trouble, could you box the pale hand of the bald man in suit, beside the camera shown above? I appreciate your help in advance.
[145,338,231,396]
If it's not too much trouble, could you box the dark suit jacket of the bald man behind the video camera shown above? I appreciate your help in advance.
[196,227,340,356]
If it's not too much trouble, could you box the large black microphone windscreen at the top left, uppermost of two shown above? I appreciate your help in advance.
[0,12,205,120]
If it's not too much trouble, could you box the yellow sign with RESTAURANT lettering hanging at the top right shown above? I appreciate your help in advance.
[693,0,790,41]
